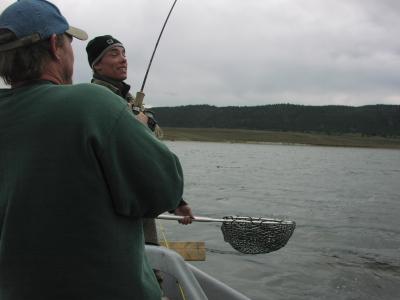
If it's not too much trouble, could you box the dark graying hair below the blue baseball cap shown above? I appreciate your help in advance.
[0,29,64,85]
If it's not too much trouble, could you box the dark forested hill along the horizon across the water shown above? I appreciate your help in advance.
[153,104,400,136]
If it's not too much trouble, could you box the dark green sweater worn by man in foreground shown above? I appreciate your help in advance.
[0,83,183,300]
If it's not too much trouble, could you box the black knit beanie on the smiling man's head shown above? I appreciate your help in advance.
[86,35,124,69]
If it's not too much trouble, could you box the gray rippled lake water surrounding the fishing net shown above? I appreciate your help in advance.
[158,142,400,300]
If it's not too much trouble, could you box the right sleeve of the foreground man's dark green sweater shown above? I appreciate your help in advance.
[99,108,183,217]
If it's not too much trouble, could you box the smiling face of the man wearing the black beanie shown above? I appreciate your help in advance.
[93,47,128,81]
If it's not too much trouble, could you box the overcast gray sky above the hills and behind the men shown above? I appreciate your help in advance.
[0,0,400,106]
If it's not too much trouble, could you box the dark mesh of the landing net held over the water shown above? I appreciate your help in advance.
[221,216,296,254]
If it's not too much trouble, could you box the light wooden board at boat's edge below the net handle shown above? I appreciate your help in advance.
[159,241,206,261]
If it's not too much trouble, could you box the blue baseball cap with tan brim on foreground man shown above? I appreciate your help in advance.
[0,0,88,51]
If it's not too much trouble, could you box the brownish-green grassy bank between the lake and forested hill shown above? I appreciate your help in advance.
[163,127,400,149]
